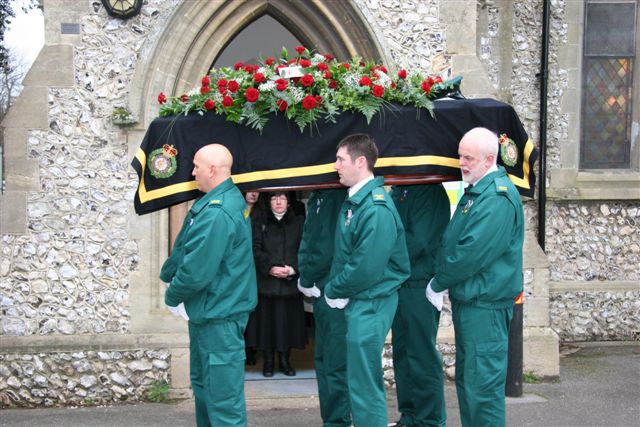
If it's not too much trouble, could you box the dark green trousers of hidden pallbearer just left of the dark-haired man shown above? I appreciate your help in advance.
[313,296,351,427]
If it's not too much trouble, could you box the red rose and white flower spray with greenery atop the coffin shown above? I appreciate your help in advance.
[158,46,461,132]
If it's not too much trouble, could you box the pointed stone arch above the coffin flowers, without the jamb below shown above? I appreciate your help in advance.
[130,0,386,128]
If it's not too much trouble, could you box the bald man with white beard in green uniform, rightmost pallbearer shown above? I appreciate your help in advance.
[427,128,524,426]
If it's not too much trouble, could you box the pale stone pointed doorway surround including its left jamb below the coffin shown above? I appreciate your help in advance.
[129,0,389,387]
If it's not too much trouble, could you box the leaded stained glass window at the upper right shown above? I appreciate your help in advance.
[580,1,636,169]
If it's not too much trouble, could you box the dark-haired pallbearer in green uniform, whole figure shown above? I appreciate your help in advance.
[324,134,410,427]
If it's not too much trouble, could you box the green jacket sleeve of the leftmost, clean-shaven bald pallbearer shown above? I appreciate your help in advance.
[164,207,233,307]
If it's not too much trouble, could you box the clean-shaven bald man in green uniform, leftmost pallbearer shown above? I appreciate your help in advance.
[160,144,257,427]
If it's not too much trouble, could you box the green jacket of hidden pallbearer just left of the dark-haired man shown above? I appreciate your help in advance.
[298,188,347,289]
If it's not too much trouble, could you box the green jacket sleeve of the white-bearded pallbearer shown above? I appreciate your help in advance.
[431,196,517,292]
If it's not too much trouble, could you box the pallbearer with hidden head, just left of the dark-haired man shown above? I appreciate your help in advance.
[298,188,351,427]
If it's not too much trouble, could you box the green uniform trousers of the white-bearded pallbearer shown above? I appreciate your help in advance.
[452,303,513,427]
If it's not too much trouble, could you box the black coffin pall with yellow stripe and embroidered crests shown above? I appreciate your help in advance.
[131,99,537,214]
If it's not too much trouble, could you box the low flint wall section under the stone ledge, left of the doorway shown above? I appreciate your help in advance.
[0,349,171,408]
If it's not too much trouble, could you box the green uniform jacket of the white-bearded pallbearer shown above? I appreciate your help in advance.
[431,167,524,308]
